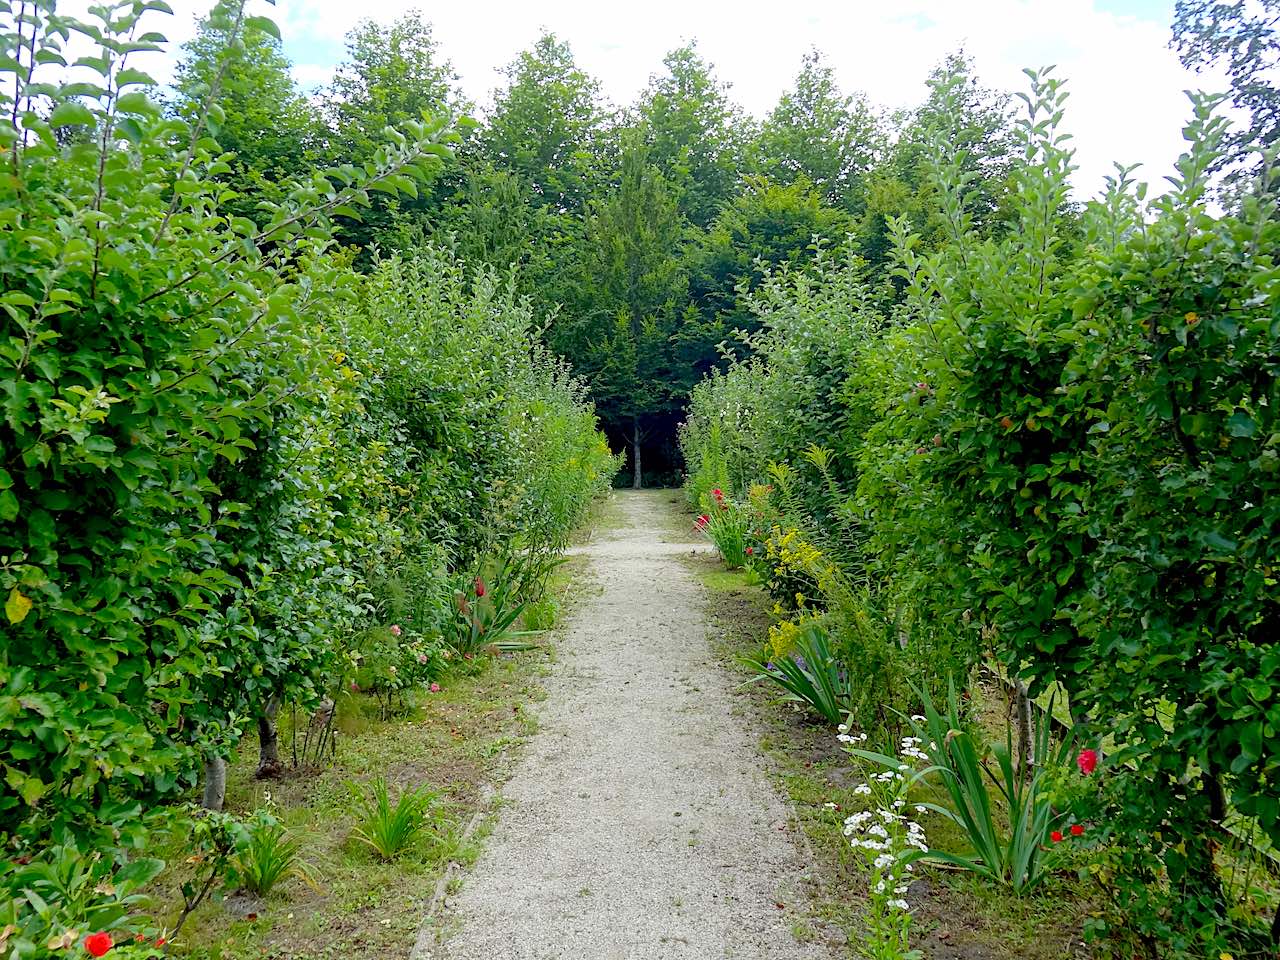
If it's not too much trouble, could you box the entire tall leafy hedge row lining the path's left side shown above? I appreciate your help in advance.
[0,0,617,957]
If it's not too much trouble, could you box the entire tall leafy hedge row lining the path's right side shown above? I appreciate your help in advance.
[682,69,1280,957]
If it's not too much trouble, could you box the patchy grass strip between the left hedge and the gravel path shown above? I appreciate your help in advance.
[149,547,585,960]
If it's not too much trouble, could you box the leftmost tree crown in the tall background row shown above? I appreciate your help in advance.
[169,15,328,225]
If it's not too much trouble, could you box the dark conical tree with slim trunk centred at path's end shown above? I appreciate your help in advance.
[553,134,691,488]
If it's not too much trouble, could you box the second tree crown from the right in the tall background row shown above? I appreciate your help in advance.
[751,50,887,210]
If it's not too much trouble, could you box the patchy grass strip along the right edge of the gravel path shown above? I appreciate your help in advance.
[687,557,1089,960]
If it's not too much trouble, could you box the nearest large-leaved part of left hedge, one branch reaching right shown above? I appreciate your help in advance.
[0,4,448,844]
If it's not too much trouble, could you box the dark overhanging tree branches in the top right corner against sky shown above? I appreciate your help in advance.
[1170,0,1280,185]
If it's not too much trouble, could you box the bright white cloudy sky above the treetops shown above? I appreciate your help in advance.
[77,0,1226,196]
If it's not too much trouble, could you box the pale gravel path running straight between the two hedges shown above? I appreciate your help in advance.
[413,492,831,960]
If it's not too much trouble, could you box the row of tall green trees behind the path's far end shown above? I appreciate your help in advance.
[160,6,1011,483]
